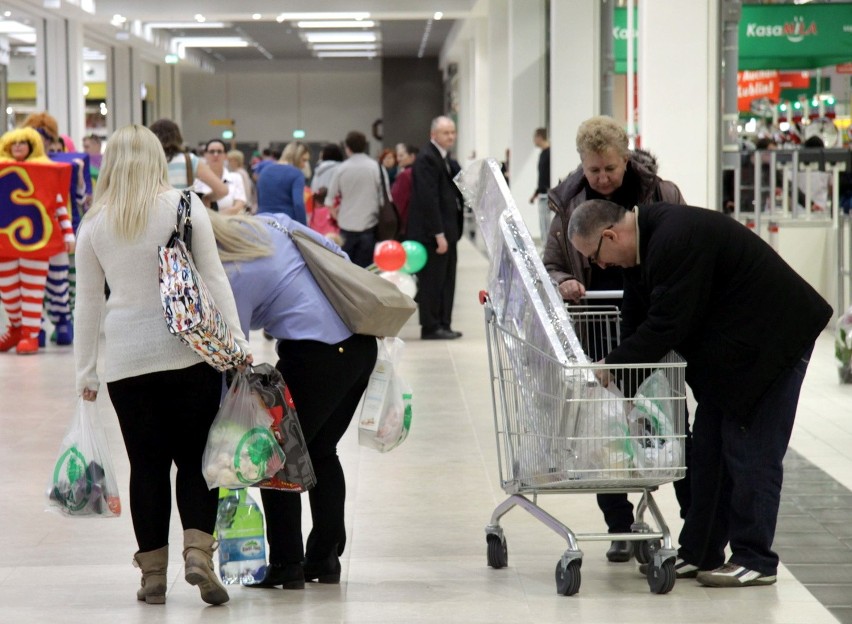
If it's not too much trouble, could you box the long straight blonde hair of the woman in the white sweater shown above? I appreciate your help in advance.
[88,124,171,240]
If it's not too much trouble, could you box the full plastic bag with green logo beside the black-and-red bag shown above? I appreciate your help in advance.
[201,372,284,489]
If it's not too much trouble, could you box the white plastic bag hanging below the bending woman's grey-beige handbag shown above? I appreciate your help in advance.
[358,338,411,453]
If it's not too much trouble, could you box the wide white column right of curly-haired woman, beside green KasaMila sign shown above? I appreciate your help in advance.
[640,0,720,209]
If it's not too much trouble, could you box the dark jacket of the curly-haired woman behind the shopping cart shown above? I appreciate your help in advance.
[542,150,686,288]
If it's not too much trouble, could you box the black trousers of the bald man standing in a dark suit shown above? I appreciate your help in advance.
[417,242,458,333]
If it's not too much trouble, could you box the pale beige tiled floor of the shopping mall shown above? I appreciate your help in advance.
[0,236,852,624]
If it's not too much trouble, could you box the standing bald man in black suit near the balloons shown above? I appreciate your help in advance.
[408,116,462,340]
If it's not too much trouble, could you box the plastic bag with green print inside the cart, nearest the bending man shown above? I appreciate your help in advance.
[627,370,683,477]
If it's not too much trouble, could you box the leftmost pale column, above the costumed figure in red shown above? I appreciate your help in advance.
[36,17,85,147]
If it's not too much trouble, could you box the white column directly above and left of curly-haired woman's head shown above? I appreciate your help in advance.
[549,0,601,186]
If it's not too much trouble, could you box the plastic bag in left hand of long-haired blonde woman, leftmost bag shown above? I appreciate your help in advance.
[47,398,121,518]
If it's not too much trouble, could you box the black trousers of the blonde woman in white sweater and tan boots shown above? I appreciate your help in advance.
[107,364,222,552]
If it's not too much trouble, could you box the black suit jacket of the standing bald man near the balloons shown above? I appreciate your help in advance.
[406,142,462,249]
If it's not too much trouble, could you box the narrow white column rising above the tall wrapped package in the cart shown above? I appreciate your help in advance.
[509,0,546,229]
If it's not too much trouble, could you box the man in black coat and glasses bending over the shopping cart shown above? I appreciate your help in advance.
[568,199,831,587]
